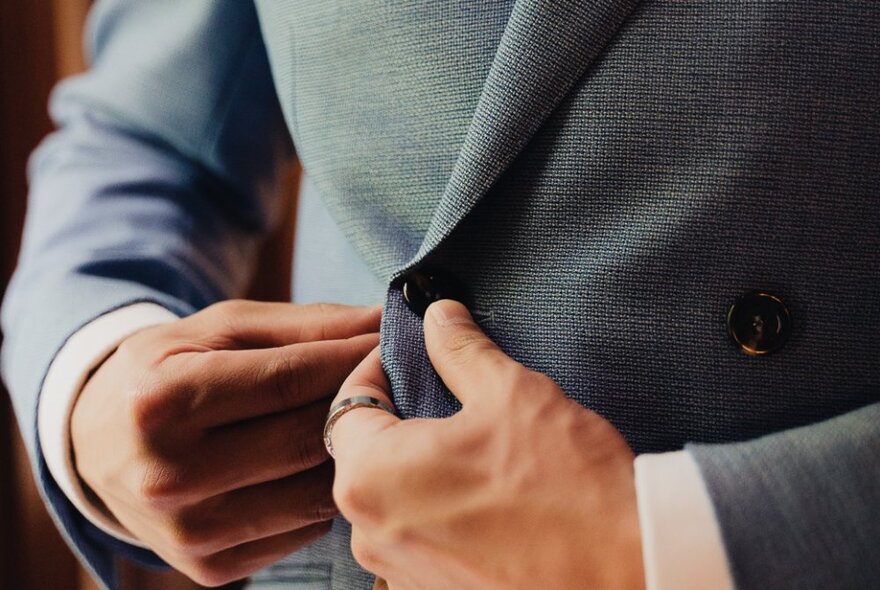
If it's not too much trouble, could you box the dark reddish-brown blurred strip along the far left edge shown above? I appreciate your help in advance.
[0,0,77,590]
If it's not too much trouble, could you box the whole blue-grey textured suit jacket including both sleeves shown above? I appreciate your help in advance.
[4,0,880,588]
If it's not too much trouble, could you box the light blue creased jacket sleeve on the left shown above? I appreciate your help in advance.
[2,0,292,587]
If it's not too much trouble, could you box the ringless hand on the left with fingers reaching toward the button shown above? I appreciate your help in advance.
[71,301,381,585]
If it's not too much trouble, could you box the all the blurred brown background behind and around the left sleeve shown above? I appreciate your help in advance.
[0,0,297,590]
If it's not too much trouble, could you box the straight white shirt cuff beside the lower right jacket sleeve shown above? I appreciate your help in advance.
[635,451,733,590]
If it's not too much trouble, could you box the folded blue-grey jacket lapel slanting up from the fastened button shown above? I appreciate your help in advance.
[397,0,638,276]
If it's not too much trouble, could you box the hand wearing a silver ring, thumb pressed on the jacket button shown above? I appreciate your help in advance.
[332,300,644,590]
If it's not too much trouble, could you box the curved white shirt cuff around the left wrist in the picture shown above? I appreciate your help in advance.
[37,303,178,547]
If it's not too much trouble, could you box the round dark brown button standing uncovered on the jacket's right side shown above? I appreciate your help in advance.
[727,291,791,356]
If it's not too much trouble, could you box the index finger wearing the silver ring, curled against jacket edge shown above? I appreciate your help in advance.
[330,346,400,462]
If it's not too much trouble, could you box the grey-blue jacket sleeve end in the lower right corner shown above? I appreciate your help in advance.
[689,403,880,590]
